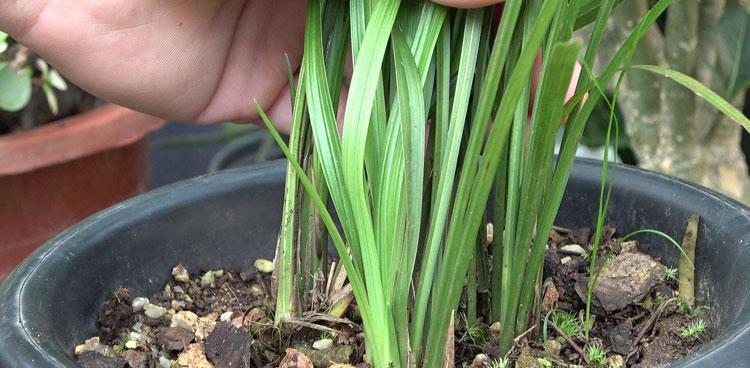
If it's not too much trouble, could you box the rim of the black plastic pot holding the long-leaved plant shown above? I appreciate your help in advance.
[0,159,750,367]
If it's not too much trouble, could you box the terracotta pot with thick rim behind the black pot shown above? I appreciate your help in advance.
[0,105,163,281]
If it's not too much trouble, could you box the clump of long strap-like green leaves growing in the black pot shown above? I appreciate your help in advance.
[253,0,750,367]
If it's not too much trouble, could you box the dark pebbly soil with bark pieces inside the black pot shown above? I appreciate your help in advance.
[76,228,709,368]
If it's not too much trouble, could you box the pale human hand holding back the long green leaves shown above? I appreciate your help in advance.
[0,0,500,131]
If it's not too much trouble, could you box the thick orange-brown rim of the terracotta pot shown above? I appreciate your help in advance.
[0,104,164,176]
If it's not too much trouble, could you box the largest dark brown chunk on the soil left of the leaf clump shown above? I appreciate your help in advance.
[204,322,253,368]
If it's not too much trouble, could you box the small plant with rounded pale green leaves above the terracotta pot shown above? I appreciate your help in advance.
[0,32,68,115]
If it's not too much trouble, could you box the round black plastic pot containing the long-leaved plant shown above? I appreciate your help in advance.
[0,161,750,368]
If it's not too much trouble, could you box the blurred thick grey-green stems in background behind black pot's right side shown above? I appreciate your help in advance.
[597,0,750,203]
